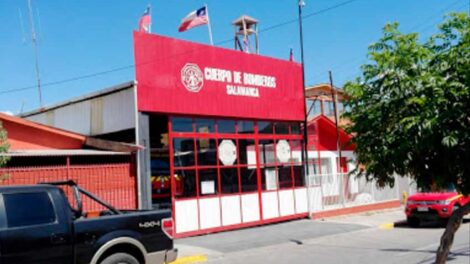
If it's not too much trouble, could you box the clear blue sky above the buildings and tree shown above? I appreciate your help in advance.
[0,0,469,114]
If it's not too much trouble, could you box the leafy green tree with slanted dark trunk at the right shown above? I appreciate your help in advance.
[345,13,470,263]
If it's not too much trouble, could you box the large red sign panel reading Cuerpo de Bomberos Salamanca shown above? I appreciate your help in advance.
[134,32,305,121]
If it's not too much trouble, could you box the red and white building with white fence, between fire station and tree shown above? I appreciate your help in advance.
[306,84,400,219]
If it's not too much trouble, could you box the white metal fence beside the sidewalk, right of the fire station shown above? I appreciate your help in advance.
[309,173,400,212]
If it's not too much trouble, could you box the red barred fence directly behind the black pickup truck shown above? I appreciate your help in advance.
[0,163,137,212]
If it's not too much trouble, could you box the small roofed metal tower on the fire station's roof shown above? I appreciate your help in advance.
[232,15,259,54]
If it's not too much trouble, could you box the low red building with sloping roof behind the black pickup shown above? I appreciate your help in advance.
[0,114,137,212]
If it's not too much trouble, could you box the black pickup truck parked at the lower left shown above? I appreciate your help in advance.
[0,181,177,264]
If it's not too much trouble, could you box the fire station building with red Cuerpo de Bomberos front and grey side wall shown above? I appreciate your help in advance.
[22,32,308,237]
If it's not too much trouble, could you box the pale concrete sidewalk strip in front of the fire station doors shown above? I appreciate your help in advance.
[175,208,405,264]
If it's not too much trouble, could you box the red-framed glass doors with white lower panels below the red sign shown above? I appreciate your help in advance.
[168,116,307,237]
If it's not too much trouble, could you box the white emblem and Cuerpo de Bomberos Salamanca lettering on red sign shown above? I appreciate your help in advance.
[181,63,276,97]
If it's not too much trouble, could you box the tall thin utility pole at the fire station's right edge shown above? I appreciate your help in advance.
[298,0,312,217]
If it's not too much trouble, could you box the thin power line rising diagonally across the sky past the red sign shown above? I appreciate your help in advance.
[0,0,359,95]
